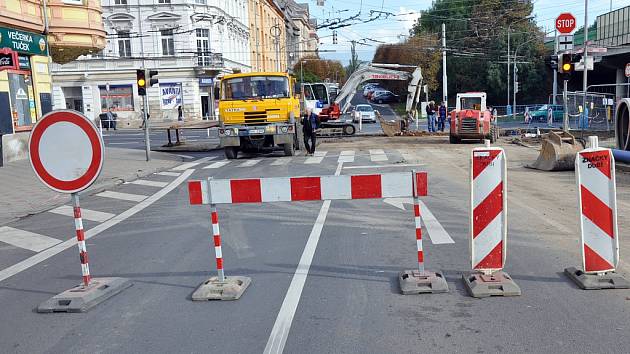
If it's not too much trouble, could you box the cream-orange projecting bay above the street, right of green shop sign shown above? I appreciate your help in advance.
[48,0,106,64]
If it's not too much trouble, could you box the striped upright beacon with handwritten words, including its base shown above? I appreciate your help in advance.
[564,136,630,289]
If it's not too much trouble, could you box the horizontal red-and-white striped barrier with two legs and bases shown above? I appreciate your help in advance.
[188,171,448,300]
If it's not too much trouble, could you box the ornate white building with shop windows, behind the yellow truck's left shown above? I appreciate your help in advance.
[53,0,251,126]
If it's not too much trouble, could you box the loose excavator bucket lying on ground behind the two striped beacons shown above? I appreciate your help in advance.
[528,131,584,171]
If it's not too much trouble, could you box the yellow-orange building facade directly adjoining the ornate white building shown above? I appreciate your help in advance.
[248,0,288,71]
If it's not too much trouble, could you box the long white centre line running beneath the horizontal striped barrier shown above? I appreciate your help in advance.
[264,162,343,354]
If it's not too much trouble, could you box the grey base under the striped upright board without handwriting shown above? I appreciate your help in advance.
[462,271,521,298]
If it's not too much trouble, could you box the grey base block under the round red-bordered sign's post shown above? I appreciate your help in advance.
[37,278,132,313]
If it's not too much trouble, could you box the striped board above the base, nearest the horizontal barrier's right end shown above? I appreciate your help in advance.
[471,148,506,270]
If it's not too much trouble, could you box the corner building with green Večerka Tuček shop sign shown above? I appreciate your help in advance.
[0,0,105,161]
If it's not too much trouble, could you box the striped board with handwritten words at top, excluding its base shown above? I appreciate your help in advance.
[576,149,619,272]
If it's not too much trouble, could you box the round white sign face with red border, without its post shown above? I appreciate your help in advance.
[28,110,104,193]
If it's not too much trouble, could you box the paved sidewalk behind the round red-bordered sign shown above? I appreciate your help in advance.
[0,148,182,226]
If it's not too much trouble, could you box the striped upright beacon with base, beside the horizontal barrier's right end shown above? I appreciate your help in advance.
[463,140,521,297]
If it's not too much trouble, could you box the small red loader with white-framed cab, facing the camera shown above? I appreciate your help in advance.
[449,92,497,144]
